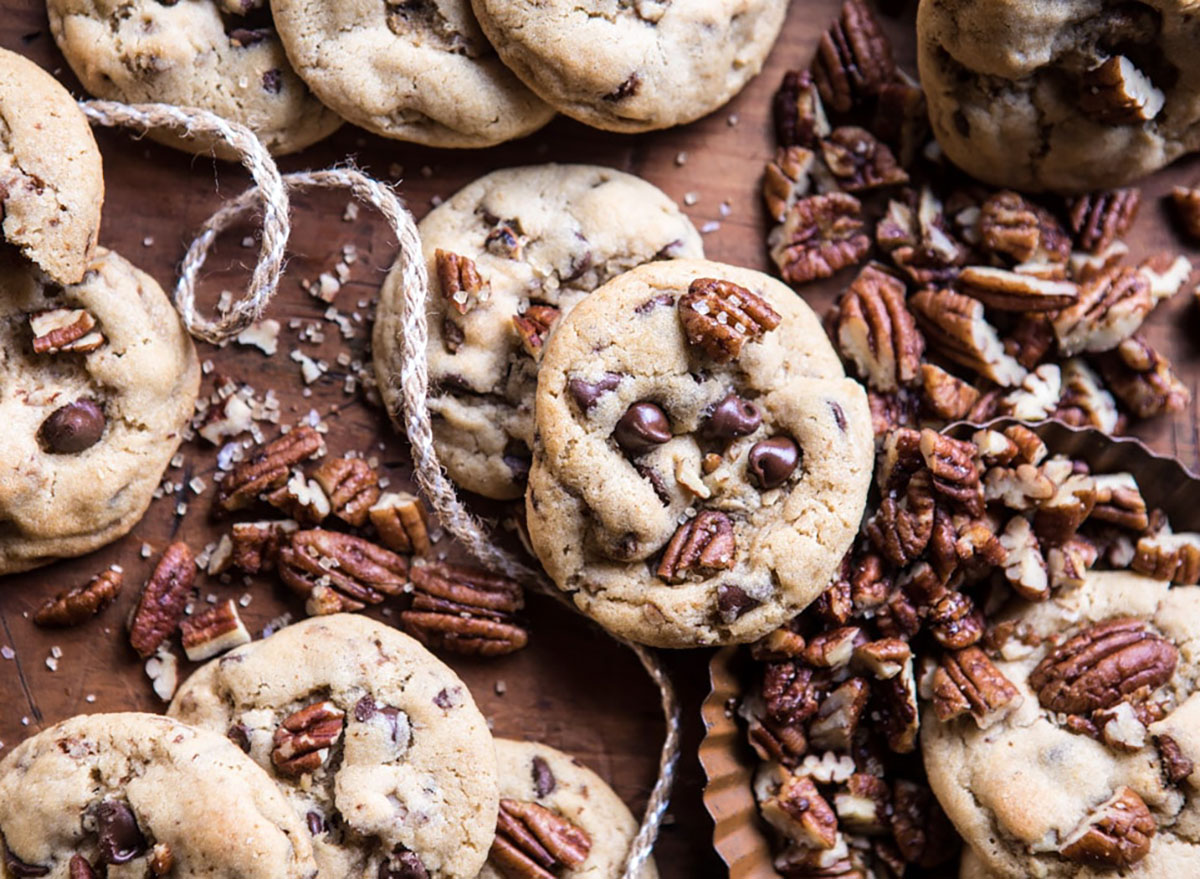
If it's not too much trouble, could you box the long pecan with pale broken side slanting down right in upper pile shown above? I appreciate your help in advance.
[908,288,1026,387]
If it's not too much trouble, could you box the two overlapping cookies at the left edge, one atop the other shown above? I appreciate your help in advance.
[0,46,200,574]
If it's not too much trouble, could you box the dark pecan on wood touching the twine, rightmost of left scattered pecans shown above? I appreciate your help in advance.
[400,564,529,657]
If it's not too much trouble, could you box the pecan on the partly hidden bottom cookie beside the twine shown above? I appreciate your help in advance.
[487,799,592,879]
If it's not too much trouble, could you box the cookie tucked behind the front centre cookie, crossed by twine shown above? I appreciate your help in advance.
[374,165,704,498]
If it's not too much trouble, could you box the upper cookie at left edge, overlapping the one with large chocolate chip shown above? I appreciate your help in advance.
[0,49,104,283]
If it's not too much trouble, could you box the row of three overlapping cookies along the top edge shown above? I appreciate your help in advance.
[47,0,786,157]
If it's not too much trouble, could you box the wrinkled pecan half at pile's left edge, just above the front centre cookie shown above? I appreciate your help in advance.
[768,192,871,285]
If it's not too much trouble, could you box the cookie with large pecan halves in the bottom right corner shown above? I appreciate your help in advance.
[922,572,1200,879]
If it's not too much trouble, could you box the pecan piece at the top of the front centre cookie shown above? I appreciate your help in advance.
[678,277,782,363]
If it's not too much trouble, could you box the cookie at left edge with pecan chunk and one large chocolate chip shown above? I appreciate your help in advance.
[0,247,200,574]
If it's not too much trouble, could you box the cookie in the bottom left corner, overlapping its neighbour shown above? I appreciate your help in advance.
[0,713,317,879]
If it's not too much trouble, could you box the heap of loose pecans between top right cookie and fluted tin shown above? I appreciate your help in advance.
[763,0,1200,435]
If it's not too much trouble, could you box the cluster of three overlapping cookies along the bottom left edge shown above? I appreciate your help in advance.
[0,615,658,879]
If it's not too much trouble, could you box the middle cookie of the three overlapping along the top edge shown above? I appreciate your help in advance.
[271,0,554,147]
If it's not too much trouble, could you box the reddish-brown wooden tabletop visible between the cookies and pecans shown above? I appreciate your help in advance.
[0,0,1200,879]
